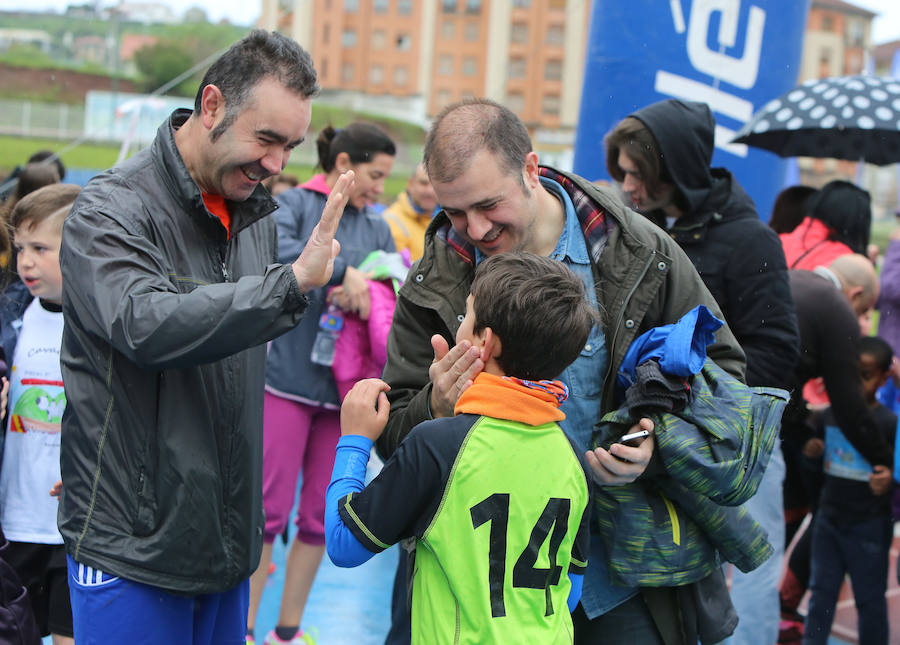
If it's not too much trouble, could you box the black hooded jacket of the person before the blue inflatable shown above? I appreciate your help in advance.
[631,100,799,388]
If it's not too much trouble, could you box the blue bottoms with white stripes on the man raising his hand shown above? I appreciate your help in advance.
[66,556,250,645]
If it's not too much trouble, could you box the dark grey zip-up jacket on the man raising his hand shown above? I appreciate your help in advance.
[59,110,307,594]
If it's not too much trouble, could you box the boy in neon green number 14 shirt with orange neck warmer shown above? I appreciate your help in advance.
[325,253,624,644]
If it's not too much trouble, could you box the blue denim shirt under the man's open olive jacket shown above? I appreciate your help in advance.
[475,177,638,619]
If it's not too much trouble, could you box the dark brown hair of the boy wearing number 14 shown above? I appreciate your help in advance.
[471,252,599,380]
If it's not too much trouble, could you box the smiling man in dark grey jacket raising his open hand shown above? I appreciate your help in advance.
[59,31,352,645]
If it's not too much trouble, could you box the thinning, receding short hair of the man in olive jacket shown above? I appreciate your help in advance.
[423,98,532,186]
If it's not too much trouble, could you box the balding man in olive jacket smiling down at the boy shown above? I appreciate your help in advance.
[378,99,744,645]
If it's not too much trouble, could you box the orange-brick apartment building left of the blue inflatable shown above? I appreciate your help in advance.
[260,0,591,131]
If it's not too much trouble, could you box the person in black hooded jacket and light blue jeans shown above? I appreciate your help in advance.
[605,100,799,645]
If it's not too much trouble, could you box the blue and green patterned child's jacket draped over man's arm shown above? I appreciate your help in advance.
[594,360,787,587]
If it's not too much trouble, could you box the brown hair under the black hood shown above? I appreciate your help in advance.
[603,116,673,199]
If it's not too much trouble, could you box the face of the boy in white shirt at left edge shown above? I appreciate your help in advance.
[13,218,62,304]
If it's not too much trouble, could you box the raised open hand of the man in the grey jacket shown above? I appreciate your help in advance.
[292,170,353,293]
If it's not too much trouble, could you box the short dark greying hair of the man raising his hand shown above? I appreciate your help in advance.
[194,29,319,141]
